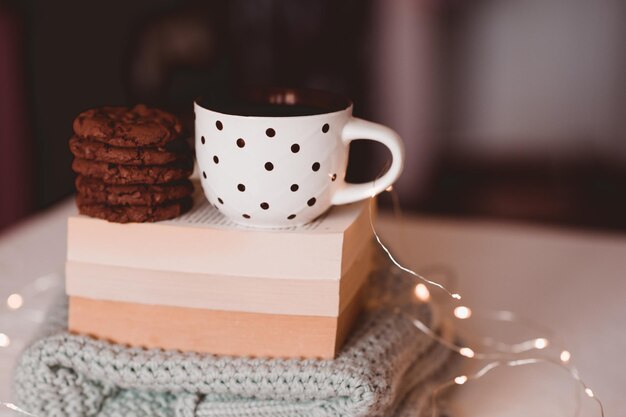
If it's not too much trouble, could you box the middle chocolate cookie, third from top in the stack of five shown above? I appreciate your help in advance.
[72,158,193,184]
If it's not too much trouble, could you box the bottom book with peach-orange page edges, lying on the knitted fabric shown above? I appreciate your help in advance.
[69,286,361,359]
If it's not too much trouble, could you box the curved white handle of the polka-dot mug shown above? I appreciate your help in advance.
[331,117,404,205]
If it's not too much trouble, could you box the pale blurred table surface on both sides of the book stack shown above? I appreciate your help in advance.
[0,201,626,417]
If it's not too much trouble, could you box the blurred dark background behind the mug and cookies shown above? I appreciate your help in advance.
[0,0,626,231]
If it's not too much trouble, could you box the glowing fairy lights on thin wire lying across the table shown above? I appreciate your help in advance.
[0,187,604,417]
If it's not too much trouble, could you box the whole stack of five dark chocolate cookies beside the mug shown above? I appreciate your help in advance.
[70,105,193,223]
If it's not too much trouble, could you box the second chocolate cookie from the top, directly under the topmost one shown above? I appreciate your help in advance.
[70,136,192,165]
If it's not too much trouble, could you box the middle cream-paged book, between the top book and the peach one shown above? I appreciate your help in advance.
[65,240,374,317]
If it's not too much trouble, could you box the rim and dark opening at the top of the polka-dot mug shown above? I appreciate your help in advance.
[194,86,353,118]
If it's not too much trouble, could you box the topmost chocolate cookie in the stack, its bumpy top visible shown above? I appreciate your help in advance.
[73,104,182,147]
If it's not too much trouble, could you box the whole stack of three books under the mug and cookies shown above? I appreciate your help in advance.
[66,187,373,358]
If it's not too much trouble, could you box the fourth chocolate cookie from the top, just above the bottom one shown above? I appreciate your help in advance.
[75,175,193,206]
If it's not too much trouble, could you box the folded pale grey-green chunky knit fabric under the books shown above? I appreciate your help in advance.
[14,270,450,417]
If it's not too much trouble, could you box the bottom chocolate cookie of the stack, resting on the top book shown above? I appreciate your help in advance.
[76,195,192,223]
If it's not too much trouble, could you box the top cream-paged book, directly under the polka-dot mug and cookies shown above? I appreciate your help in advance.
[67,185,372,280]
